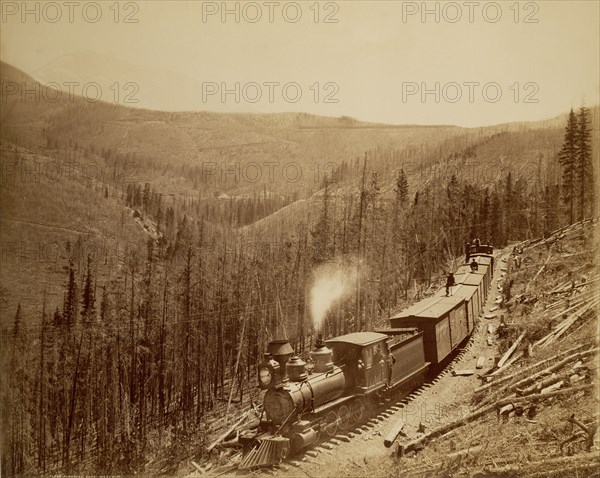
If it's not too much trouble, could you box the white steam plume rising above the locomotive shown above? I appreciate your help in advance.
[310,263,356,329]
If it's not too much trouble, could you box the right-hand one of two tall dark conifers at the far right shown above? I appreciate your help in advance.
[574,106,593,220]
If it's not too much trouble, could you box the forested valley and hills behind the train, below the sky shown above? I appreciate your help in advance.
[0,59,598,474]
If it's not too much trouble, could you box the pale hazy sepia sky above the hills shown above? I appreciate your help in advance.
[0,1,600,126]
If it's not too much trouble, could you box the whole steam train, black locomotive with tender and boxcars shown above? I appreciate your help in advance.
[239,244,494,468]
